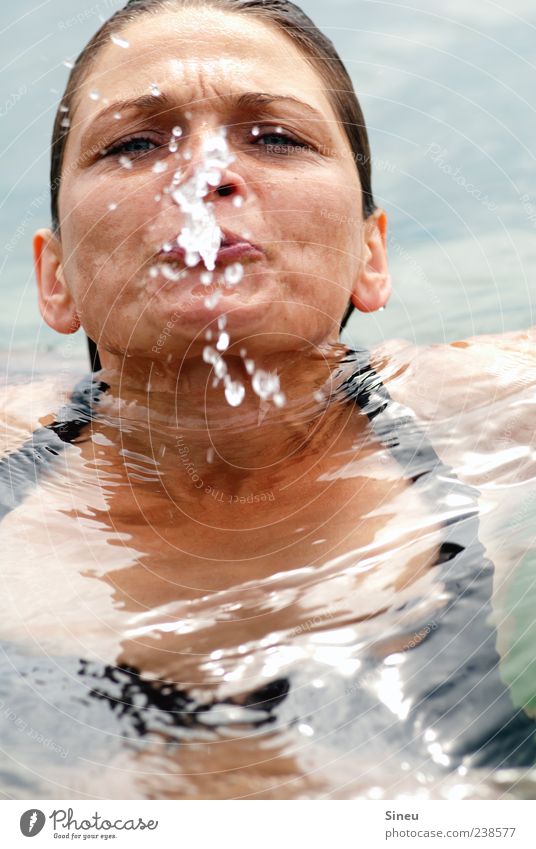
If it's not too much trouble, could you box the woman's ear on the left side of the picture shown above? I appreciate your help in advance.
[33,228,80,333]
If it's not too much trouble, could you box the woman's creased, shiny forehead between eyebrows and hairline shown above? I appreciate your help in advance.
[77,7,337,122]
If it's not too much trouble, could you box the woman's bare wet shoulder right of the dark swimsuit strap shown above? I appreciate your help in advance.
[372,330,536,421]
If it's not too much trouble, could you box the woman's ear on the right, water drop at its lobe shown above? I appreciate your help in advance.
[351,209,391,312]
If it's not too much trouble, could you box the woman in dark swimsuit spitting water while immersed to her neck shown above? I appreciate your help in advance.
[3,0,535,798]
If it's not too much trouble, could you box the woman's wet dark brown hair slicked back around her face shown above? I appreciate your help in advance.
[50,0,376,330]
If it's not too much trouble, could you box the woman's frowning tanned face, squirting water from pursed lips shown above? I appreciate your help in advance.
[38,8,389,361]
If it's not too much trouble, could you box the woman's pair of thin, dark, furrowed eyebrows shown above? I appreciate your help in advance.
[77,91,326,147]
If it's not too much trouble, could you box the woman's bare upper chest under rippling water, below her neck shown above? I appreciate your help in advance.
[0,438,439,665]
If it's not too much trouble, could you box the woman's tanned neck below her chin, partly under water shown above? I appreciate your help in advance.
[94,343,358,498]
